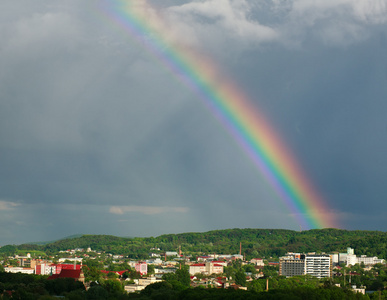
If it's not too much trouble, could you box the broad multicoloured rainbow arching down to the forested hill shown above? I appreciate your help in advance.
[101,0,338,229]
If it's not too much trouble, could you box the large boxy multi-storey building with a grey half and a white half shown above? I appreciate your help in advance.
[279,253,332,278]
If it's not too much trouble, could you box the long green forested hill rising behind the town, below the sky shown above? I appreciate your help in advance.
[0,229,387,258]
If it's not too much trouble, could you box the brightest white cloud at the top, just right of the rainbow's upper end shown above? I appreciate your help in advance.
[168,0,278,46]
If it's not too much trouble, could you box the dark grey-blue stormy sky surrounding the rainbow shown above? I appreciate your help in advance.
[0,0,387,245]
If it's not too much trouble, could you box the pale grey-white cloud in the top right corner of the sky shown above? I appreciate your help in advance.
[277,0,387,46]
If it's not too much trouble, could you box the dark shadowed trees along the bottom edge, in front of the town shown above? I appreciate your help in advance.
[0,272,374,300]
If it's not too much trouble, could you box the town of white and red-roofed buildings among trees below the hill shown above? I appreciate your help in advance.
[0,229,387,299]
